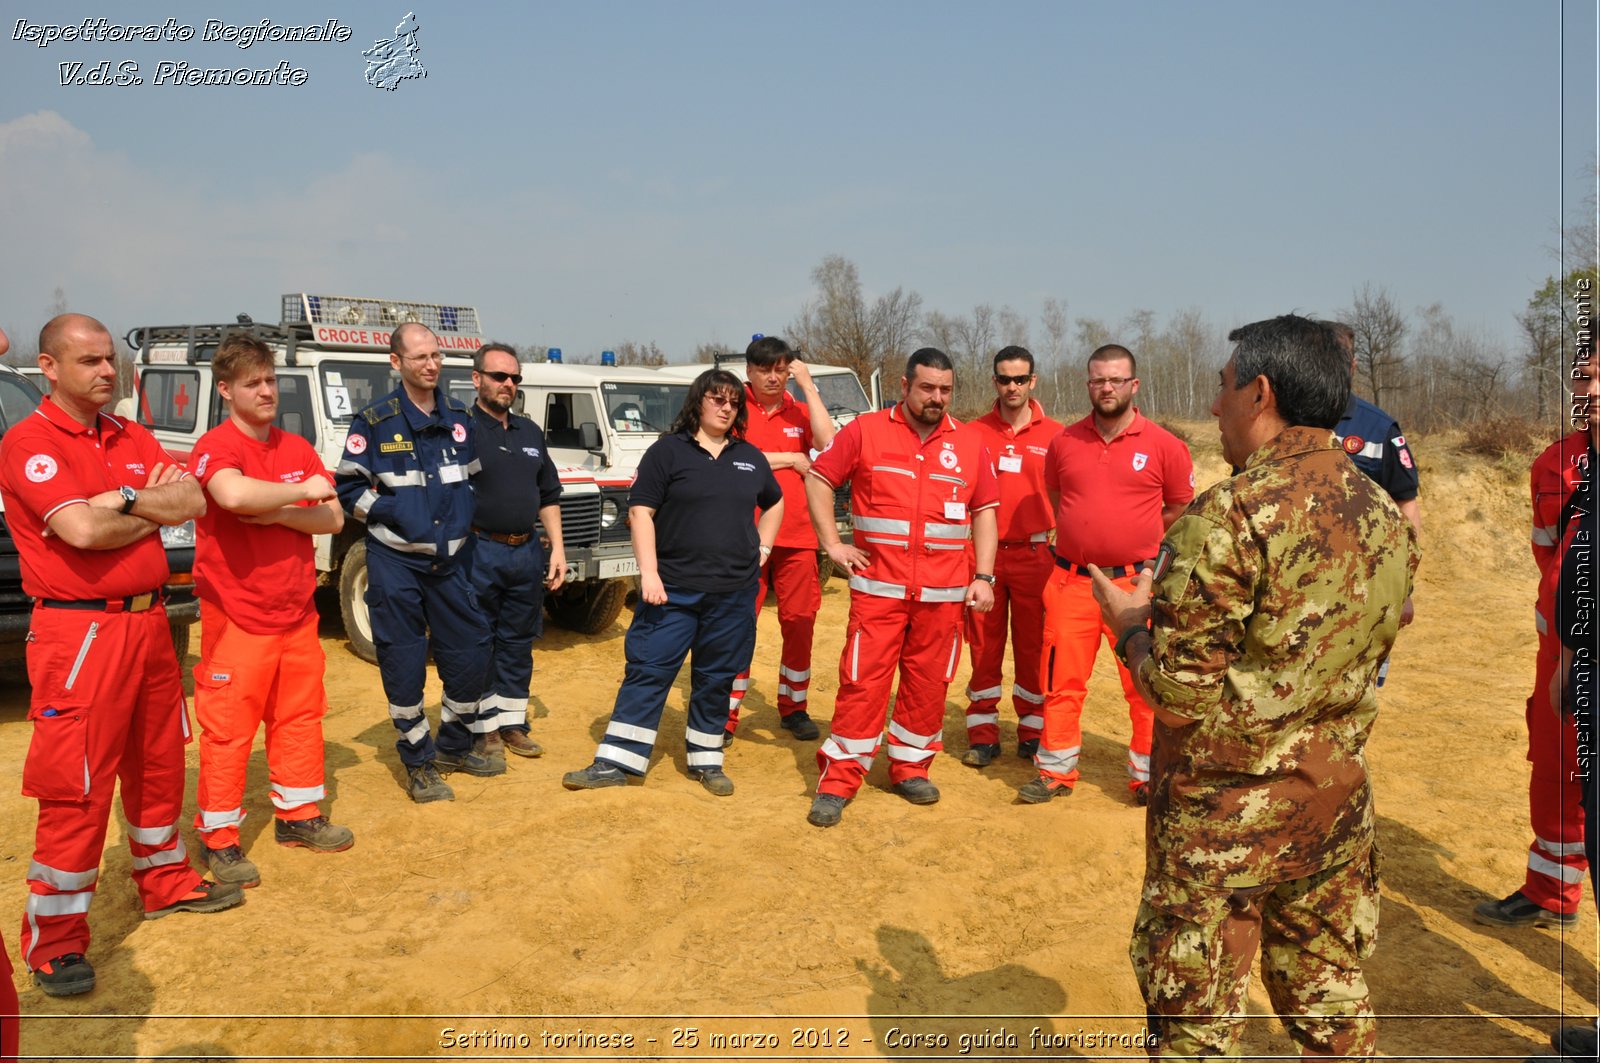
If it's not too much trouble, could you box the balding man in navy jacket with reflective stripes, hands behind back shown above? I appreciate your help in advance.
[334,322,489,804]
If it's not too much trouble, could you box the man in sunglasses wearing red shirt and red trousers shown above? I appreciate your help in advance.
[962,347,1061,768]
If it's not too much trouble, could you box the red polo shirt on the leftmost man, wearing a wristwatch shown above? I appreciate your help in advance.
[0,395,181,600]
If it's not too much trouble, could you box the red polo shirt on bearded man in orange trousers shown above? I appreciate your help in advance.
[1045,408,1195,565]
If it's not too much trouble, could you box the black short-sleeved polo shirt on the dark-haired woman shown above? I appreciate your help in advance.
[627,432,784,594]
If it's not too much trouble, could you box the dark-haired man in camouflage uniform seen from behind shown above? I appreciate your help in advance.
[1094,317,1418,1058]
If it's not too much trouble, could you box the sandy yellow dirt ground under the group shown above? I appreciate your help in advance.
[0,426,1597,1060]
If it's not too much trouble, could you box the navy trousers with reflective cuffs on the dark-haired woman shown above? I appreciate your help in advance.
[595,583,755,775]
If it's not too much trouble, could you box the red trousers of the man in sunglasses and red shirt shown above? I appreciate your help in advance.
[966,543,1056,746]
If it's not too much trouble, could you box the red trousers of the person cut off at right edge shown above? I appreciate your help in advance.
[1522,634,1589,913]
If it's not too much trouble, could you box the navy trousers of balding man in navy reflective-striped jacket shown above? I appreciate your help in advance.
[366,540,490,768]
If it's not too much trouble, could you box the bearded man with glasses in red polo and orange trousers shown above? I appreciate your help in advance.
[1018,343,1195,805]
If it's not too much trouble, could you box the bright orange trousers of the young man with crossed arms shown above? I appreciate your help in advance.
[195,600,328,848]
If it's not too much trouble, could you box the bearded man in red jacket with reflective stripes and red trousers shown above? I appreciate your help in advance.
[806,347,1000,826]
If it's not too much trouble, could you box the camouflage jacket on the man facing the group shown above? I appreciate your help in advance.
[1141,427,1419,889]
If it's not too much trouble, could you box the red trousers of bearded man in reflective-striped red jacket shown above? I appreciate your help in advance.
[816,591,965,799]
